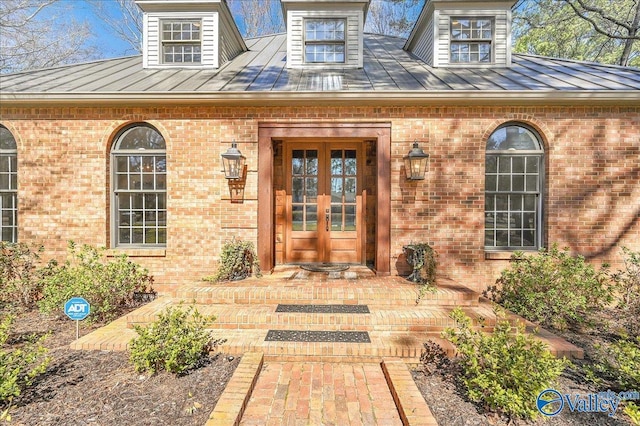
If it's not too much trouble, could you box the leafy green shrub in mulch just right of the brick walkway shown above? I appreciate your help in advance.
[444,308,568,418]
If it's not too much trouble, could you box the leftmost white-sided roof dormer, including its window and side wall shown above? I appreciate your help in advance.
[136,0,247,69]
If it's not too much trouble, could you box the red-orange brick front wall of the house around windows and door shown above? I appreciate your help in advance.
[0,106,640,290]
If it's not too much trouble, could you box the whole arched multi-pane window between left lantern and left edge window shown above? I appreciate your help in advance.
[111,124,167,247]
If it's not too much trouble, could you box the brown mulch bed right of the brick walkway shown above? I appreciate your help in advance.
[413,312,631,426]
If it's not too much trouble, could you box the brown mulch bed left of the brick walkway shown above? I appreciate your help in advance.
[0,312,239,425]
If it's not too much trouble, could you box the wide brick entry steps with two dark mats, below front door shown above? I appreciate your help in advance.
[71,268,583,362]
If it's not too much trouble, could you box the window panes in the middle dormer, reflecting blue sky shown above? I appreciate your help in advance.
[304,19,345,63]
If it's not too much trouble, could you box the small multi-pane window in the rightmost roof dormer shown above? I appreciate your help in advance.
[450,18,493,64]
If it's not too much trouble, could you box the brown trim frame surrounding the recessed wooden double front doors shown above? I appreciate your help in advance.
[258,122,391,275]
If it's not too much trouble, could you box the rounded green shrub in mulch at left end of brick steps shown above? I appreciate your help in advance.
[130,307,221,374]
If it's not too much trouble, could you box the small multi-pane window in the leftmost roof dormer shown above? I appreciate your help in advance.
[162,20,202,64]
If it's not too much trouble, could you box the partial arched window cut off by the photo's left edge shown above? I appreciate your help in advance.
[0,126,18,243]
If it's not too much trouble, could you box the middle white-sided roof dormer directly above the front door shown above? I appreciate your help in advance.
[281,0,369,69]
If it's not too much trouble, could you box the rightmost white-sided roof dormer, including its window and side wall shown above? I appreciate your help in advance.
[404,0,515,68]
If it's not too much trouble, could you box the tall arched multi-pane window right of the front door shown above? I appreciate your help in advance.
[484,123,544,250]
